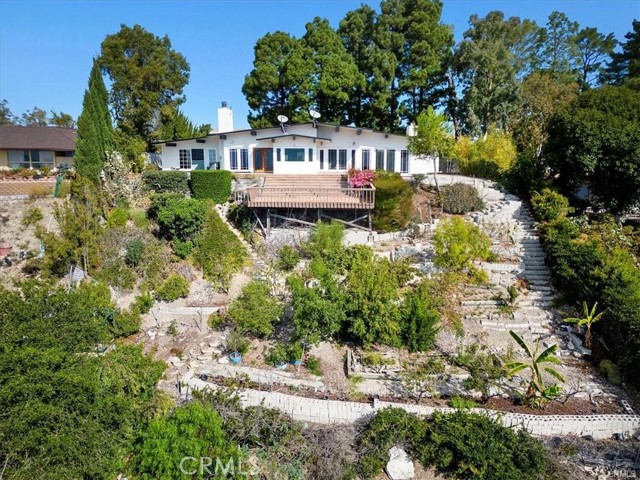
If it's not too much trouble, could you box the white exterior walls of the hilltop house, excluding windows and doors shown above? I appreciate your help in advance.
[162,124,438,176]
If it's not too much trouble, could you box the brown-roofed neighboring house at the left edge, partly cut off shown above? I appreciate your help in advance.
[0,125,77,169]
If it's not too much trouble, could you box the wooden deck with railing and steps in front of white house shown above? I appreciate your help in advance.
[236,175,375,210]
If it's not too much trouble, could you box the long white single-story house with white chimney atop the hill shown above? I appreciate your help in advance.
[158,102,438,176]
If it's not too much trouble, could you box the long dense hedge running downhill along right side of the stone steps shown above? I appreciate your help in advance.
[533,193,640,385]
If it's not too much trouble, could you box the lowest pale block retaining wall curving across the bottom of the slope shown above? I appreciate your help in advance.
[229,388,640,440]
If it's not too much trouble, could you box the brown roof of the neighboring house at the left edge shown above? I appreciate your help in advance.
[0,125,77,152]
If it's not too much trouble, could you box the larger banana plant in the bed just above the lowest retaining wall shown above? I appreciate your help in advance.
[507,330,565,404]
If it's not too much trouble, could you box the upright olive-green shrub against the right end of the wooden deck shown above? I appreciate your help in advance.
[372,173,413,232]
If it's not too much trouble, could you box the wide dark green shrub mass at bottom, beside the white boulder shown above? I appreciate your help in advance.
[359,408,545,480]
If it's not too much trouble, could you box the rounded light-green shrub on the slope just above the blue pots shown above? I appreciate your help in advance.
[228,280,283,337]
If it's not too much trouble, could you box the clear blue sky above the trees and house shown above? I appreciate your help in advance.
[0,0,640,127]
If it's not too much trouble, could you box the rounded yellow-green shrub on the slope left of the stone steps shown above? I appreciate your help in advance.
[433,217,491,272]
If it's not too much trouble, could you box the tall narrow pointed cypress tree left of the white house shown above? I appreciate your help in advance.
[75,59,113,183]
